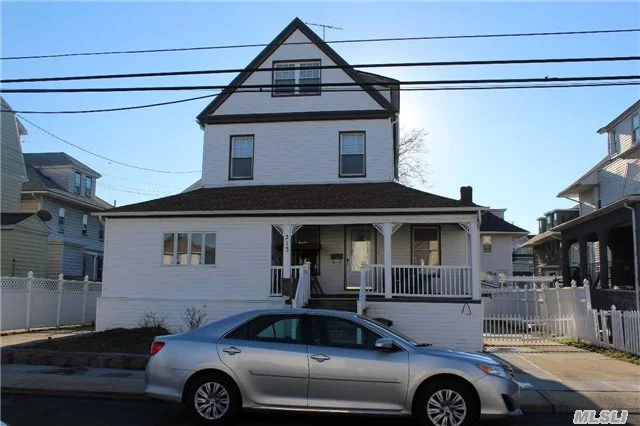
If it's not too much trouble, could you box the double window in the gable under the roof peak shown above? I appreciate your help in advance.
[271,61,321,96]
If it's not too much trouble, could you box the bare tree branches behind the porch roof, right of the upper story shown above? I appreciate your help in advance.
[397,129,429,186]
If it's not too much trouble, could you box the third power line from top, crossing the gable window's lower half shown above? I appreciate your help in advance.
[0,75,640,93]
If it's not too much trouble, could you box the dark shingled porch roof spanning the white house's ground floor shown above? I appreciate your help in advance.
[98,182,485,216]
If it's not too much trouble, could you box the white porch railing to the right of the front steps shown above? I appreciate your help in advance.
[361,265,472,297]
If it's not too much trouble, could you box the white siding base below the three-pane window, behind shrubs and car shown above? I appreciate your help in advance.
[96,296,284,332]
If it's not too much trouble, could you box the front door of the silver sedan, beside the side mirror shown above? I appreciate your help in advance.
[308,315,409,411]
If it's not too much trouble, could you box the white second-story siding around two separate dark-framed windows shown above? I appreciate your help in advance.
[202,120,393,187]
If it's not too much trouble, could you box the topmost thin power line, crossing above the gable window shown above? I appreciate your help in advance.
[0,28,640,61]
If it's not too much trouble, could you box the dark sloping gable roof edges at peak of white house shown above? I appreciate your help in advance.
[196,18,397,125]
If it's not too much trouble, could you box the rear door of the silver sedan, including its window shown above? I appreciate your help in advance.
[218,314,309,408]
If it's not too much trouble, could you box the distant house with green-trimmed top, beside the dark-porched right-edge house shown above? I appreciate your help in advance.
[520,207,580,282]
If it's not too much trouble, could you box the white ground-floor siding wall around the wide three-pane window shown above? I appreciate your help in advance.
[102,218,271,300]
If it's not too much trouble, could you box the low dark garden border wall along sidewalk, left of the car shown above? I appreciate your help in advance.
[1,347,149,370]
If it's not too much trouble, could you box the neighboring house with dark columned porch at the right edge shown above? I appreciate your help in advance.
[553,100,640,296]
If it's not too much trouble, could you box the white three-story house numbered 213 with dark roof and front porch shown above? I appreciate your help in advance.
[97,19,486,350]
